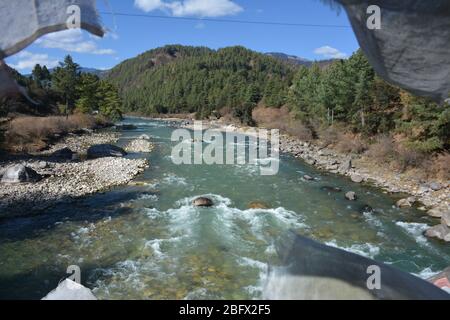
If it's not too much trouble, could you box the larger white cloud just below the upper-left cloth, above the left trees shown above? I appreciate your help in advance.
[36,29,115,55]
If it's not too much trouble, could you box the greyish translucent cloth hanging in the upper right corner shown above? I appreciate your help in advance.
[336,0,450,101]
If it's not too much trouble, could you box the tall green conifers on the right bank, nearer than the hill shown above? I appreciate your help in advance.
[288,50,450,153]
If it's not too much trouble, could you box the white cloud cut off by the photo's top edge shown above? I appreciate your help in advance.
[134,0,244,17]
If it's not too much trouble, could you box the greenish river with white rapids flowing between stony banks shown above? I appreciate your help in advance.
[0,118,450,299]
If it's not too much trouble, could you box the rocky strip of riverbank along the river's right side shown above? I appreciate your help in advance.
[142,117,450,218]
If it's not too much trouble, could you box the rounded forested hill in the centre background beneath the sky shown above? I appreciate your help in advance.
[107,45,296,118]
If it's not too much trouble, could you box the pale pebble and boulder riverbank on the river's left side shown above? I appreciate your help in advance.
[0,132,148,218]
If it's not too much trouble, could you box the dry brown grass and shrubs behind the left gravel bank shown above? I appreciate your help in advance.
[4,114,105,152]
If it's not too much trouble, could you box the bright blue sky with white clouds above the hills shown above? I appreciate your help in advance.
[7,0,358,73]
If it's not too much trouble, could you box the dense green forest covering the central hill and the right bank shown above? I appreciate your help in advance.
[108,46,450,153]
